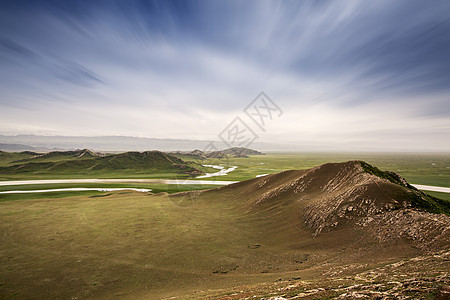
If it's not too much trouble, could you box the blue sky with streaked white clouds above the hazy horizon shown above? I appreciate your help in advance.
[0,0,450,152]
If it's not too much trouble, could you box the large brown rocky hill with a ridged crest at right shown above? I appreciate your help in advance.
[182,161,450,249]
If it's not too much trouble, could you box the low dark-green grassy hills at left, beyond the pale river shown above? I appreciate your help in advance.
[0,149,203,177]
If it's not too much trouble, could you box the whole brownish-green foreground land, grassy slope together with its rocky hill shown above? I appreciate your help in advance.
[0,161,450,299]
